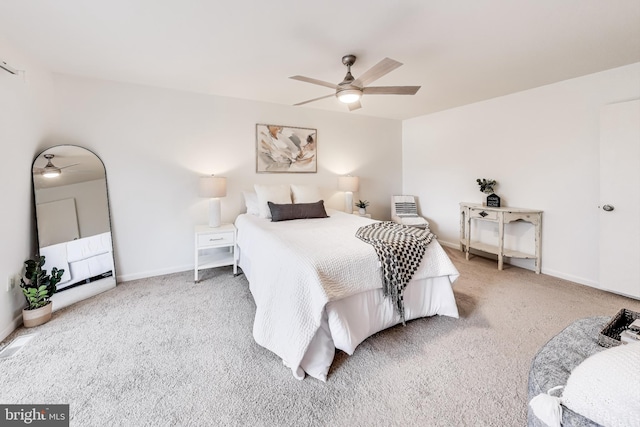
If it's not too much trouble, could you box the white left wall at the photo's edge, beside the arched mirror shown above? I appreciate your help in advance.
[0,36,53,340]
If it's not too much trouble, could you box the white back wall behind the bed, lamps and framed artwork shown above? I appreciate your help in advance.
[54,75,402,280]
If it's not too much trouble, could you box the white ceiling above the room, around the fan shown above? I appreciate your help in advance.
[0,0,640,119]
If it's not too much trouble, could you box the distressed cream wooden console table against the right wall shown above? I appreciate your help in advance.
[460,202,542,274]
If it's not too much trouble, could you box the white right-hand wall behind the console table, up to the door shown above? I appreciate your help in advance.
[402,63,640,286]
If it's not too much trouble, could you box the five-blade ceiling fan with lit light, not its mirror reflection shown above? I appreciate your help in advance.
[289,55,420,111]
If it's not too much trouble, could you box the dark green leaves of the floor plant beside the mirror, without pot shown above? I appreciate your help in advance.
[20,255,64,310]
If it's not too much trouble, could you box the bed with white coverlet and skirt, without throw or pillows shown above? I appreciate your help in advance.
[235,210,459,381]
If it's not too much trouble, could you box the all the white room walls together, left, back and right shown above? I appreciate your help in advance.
[5,51,640,339]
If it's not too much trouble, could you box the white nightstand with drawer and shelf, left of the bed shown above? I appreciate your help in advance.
[194,224,238,282]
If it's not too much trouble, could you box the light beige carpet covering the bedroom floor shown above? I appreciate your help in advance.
[0,250,640,426]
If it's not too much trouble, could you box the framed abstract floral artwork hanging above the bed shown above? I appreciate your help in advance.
[256,124,318,173]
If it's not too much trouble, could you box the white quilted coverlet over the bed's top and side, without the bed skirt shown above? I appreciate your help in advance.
[236,211,458,380]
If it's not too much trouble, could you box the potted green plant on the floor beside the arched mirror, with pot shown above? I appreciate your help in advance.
[20,255,64,328]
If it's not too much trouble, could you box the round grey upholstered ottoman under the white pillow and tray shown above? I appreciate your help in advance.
[527,316,610,427]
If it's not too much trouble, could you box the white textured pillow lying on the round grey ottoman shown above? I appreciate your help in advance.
[562,343,640,427]
